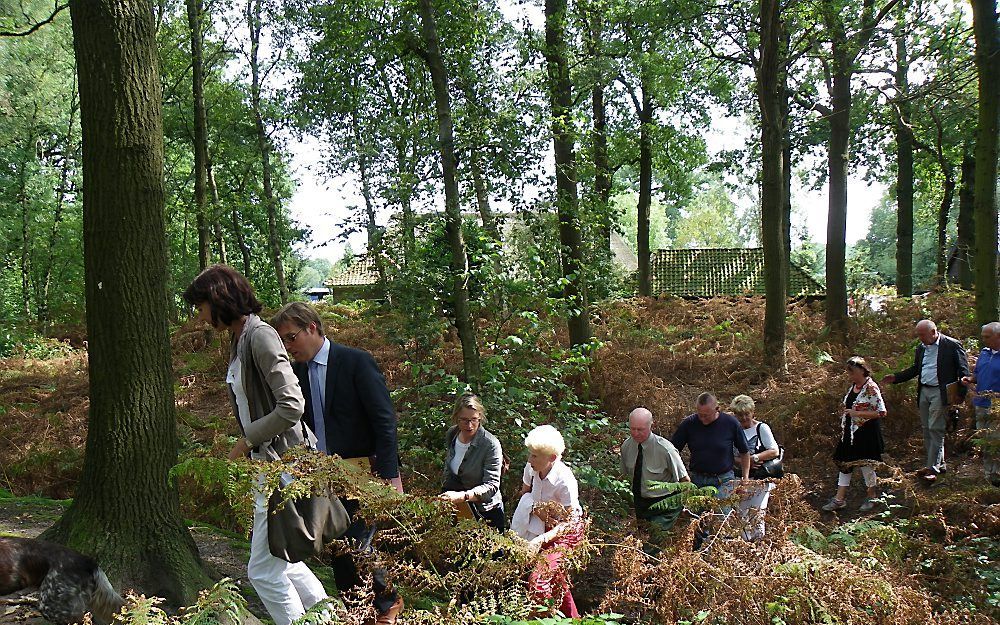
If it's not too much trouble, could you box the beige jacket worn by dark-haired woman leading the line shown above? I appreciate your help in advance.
[230,315,316,460]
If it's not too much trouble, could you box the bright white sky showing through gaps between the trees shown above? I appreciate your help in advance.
[289,1,885,261]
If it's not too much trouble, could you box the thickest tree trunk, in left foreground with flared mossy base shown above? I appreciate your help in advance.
[45,0,209,606]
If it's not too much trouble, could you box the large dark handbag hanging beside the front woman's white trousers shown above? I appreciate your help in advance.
[267,424,351,562]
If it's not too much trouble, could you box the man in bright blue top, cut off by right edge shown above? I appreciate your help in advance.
[962,321,1000,486]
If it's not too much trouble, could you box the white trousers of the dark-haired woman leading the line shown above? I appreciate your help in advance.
[247,492,326,625]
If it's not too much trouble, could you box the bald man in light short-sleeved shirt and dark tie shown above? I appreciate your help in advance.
[621,407,691,530]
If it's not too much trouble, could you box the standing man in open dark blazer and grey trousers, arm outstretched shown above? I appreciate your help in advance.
[882,319,969,483]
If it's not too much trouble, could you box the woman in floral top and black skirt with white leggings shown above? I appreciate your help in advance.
[823,356,886,512]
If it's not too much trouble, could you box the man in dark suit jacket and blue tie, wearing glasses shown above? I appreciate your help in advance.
[271,302,403,625]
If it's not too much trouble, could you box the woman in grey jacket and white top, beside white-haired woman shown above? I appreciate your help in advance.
[441,393,507,532]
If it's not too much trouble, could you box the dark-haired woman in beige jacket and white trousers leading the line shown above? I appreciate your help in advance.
[184,265,326,625]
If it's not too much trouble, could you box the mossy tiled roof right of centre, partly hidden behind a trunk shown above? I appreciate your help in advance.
[650,247,826,297]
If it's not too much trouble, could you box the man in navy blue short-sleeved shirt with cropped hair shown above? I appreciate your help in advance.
[671,393,750,498]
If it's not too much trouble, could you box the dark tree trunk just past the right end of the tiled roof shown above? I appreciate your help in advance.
[826,53,851,336]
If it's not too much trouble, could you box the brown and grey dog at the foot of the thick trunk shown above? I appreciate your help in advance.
[0,537,124,625]
